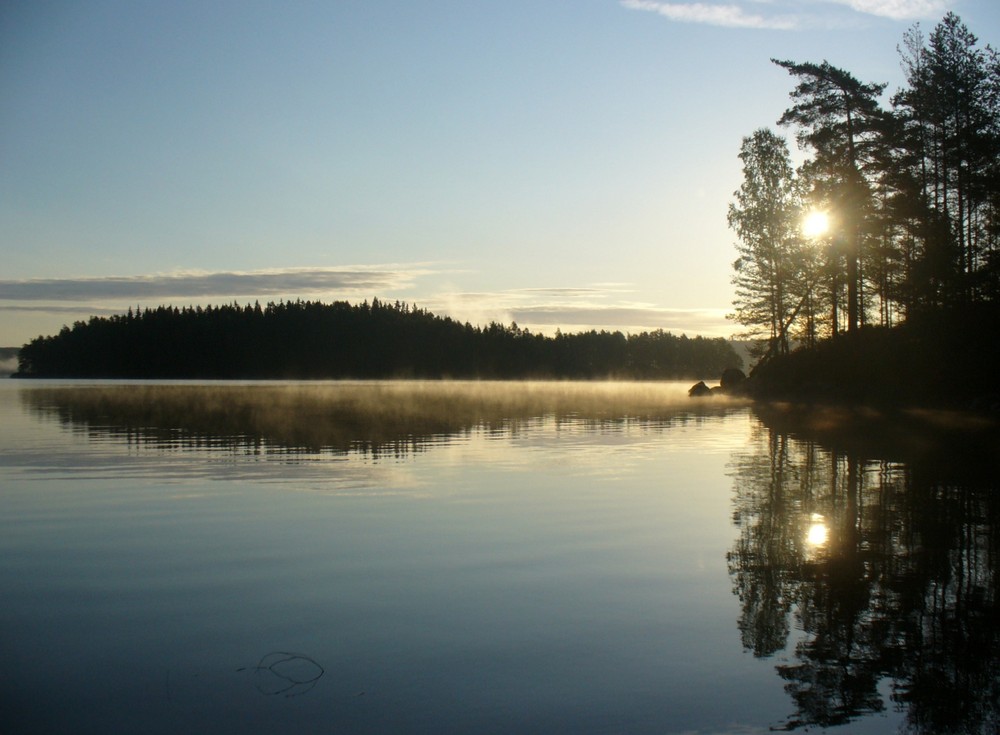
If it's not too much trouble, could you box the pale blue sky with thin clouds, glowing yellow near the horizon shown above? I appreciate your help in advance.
[0,0,1000,346]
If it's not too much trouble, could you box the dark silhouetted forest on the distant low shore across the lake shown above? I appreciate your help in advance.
[17,299,742,379]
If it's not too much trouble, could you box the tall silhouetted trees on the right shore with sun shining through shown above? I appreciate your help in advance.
[728,13,1000,402]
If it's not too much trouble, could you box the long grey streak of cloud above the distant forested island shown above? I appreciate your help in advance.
[0,266,430,302]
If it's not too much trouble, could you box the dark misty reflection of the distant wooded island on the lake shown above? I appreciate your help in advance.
[20,381,733,459]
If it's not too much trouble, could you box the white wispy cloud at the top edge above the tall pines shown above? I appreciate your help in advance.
[621,0,956,31]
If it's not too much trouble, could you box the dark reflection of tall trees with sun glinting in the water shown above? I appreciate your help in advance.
[728,407,1000,733]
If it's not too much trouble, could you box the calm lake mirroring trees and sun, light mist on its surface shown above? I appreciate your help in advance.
[0,380,1000,734]
